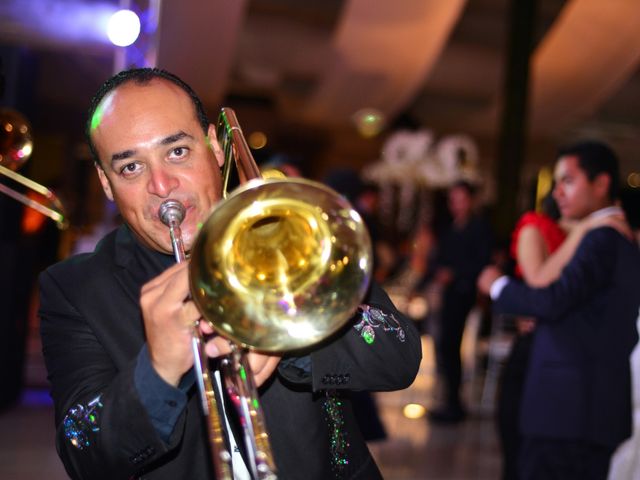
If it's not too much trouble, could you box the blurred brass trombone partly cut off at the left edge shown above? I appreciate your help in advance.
[0,109,69,230]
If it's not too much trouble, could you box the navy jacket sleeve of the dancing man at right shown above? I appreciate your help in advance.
[493,228,618,322]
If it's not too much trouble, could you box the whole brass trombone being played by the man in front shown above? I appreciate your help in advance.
[159,108,372,479]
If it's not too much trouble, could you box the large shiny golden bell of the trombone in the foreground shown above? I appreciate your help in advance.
[190,178,372,352]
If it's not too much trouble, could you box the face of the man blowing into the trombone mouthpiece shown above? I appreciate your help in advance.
[91,79,224,253]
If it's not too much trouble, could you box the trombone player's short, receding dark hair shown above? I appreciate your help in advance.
[85,68,209,165]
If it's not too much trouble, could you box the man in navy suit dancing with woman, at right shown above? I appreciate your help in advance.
[479,142,640,480]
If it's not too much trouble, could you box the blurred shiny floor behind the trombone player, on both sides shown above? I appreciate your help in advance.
[0,335,500,480]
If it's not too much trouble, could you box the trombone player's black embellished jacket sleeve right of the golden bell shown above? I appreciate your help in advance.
[279,283,422,391]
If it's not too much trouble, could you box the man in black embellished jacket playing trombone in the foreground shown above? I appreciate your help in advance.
[40,69,421,480]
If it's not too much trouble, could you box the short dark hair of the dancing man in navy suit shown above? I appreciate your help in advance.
[558,140,620,201]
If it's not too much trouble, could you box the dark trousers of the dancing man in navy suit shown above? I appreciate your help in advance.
[519,436,614,480]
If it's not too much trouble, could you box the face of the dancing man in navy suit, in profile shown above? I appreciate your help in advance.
[553,156,609,220]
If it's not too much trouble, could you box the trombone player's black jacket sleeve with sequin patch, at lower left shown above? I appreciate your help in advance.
[39,272,184,480]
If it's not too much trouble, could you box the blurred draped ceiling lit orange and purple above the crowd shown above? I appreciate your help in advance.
[0,0,640,174]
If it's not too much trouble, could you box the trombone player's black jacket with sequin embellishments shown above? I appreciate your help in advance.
[40,226,421,480]
